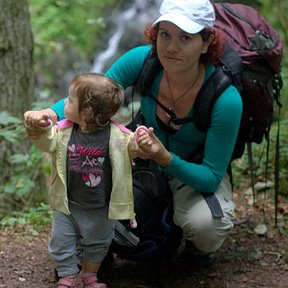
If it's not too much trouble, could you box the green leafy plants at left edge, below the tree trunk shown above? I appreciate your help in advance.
[0,111,50,217]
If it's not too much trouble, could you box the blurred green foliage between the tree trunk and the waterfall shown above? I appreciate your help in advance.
[28,0,123,100]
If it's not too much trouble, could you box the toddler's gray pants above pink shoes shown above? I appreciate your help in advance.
[48,203,115,277]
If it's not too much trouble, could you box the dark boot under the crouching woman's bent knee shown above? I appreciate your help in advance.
[183,240,215,267]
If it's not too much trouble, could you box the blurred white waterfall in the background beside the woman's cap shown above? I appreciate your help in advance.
[91,0,162,73]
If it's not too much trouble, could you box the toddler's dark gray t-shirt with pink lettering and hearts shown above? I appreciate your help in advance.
[67,124,112,208]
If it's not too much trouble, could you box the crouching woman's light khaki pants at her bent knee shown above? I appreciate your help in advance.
[169,176,235,253]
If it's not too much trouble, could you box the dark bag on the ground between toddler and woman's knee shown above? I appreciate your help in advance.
[110,158,182,262]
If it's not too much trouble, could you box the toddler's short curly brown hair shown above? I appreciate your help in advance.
[69,73,124,130]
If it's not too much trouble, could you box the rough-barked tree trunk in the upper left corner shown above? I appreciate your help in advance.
[0,0,34,116]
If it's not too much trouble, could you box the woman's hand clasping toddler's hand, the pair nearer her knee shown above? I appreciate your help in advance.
[131,127,172,166]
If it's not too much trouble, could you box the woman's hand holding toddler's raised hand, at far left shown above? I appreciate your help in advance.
[23,108,57,140]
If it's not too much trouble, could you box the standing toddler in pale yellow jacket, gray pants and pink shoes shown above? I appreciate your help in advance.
[25,73,139,288]
